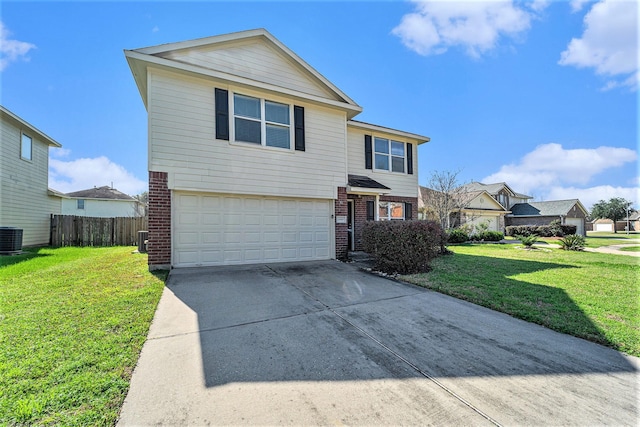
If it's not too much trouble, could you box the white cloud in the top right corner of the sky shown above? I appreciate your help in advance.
[558,0,640,91]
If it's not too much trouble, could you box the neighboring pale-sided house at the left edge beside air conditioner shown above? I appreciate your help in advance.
[0,106,62,246]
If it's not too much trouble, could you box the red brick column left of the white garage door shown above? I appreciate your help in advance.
[147,171,171,270]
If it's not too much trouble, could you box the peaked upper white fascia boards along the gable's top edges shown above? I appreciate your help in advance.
[135,28,362,111]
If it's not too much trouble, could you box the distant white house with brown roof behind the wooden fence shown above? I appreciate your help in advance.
[55,185,145,218]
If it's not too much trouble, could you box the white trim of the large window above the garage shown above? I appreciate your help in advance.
[229,90,296,152]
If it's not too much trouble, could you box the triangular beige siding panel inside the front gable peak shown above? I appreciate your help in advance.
[158,40,336,100]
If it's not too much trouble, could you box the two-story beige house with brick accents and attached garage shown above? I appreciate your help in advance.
[125,29,429,269]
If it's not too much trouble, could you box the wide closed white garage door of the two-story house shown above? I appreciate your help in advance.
[172,192,333,267]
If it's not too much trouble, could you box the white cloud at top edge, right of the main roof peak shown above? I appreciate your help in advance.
[392,0,536,58]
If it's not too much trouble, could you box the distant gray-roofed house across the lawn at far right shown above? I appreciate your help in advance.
[507,199,589,236]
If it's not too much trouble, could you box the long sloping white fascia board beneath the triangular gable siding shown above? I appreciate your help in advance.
[125,50,362,117]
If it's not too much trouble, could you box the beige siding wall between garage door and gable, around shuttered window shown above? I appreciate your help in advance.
[148,69,346,199]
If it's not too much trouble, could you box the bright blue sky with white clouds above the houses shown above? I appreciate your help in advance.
[0,0,640,208]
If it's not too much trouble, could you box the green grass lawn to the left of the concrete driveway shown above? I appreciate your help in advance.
[0,247,166,426]
